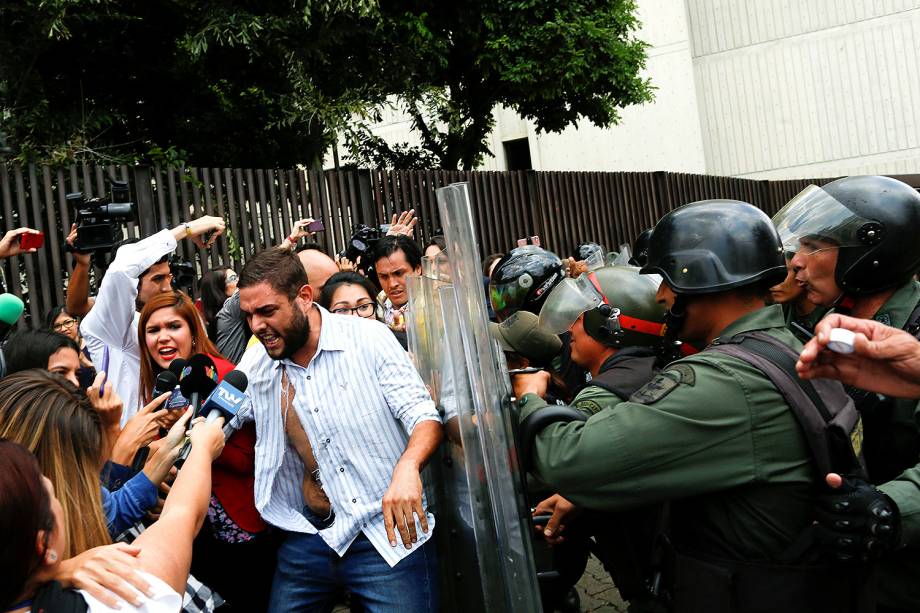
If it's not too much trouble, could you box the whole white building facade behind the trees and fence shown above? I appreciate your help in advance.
[342,0,920,179]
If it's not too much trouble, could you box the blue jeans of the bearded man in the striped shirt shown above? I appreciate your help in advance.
[268,532,438,613]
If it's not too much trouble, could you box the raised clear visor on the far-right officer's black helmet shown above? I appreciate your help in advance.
[773,185,880,254]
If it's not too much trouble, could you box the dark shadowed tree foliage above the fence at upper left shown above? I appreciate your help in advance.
[0,0,375,167]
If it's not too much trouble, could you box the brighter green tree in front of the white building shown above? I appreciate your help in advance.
[348,0,652,169]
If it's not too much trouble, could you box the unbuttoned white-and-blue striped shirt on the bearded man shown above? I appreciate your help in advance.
[234,306,440,566]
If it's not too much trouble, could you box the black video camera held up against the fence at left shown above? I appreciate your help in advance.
[66,179,137,253]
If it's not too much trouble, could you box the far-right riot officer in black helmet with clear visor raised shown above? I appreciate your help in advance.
[773,176,920,611]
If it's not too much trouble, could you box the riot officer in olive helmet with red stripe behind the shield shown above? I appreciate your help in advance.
[524,266,665,611]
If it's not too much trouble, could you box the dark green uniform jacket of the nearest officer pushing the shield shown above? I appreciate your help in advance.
[519,305,815,560]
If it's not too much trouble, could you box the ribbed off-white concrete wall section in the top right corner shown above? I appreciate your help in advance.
[687,0,920,178]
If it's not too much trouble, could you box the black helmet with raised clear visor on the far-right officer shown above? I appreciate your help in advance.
[773,176,920,296]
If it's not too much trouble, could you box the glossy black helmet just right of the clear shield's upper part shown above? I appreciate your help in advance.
[489,245,565,321]
